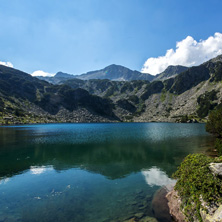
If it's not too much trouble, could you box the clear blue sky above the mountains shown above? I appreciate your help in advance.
[0,0,222,74]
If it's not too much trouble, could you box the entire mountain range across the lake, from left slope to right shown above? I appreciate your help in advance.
[0,55,222,124]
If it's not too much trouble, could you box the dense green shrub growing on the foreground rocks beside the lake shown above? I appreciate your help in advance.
[173,154,222,221]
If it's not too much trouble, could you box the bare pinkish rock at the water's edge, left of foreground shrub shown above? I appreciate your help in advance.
[166,190,186,222]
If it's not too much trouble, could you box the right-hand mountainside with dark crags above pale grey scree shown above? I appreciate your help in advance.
[133,56,222,122]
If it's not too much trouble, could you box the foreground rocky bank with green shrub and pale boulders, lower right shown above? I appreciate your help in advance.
[166,155,222,222]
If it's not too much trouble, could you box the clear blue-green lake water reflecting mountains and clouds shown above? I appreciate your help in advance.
[0,123,213,222]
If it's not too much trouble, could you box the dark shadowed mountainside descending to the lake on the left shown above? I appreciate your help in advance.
[0,66,119,124]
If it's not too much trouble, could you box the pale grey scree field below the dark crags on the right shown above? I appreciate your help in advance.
[133,80,222,122]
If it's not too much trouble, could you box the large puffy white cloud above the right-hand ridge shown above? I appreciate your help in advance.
[141,32,222,75]
